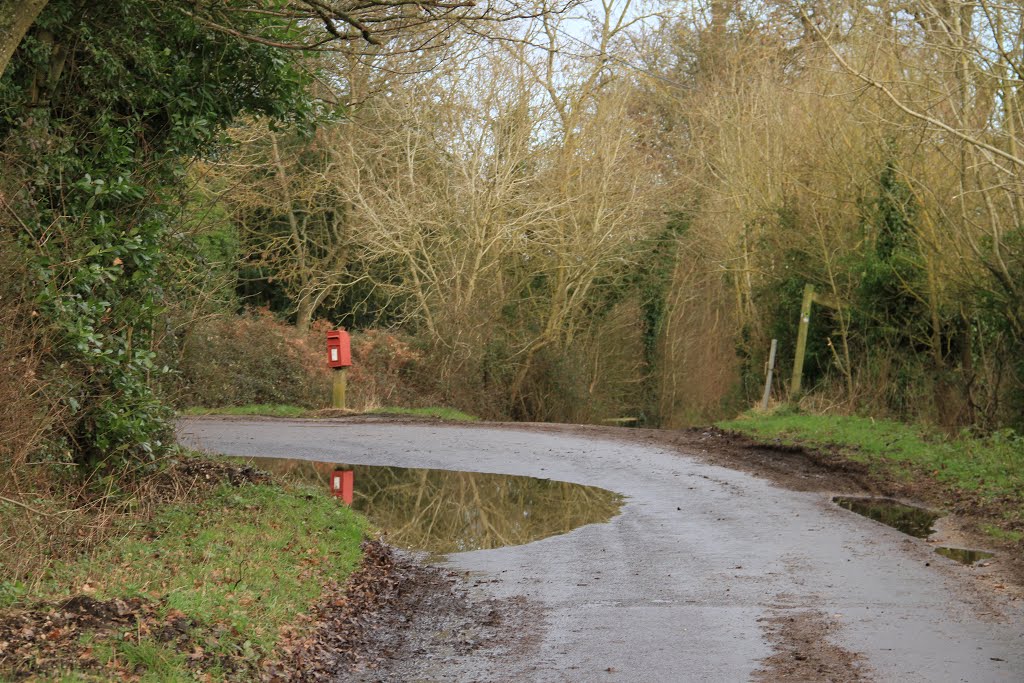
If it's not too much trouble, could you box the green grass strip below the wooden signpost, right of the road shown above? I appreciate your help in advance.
[718,412,1024,515]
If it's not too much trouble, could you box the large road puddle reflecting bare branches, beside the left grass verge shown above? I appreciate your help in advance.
[243,458,622,553]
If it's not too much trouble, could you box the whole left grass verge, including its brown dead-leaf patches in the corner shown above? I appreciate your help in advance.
[0,456,367,681]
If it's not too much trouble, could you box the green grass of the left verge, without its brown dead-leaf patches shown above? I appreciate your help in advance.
[20,482,367,681]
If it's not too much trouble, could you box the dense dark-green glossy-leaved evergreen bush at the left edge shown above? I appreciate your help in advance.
[0,0,307,465]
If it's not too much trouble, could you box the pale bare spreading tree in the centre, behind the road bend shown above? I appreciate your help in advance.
[327,15,659,413]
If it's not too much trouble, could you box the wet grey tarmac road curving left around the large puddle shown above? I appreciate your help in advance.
[178,419,1024,683]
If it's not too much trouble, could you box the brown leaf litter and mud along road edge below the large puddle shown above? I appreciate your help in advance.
[262,541,537,682]
